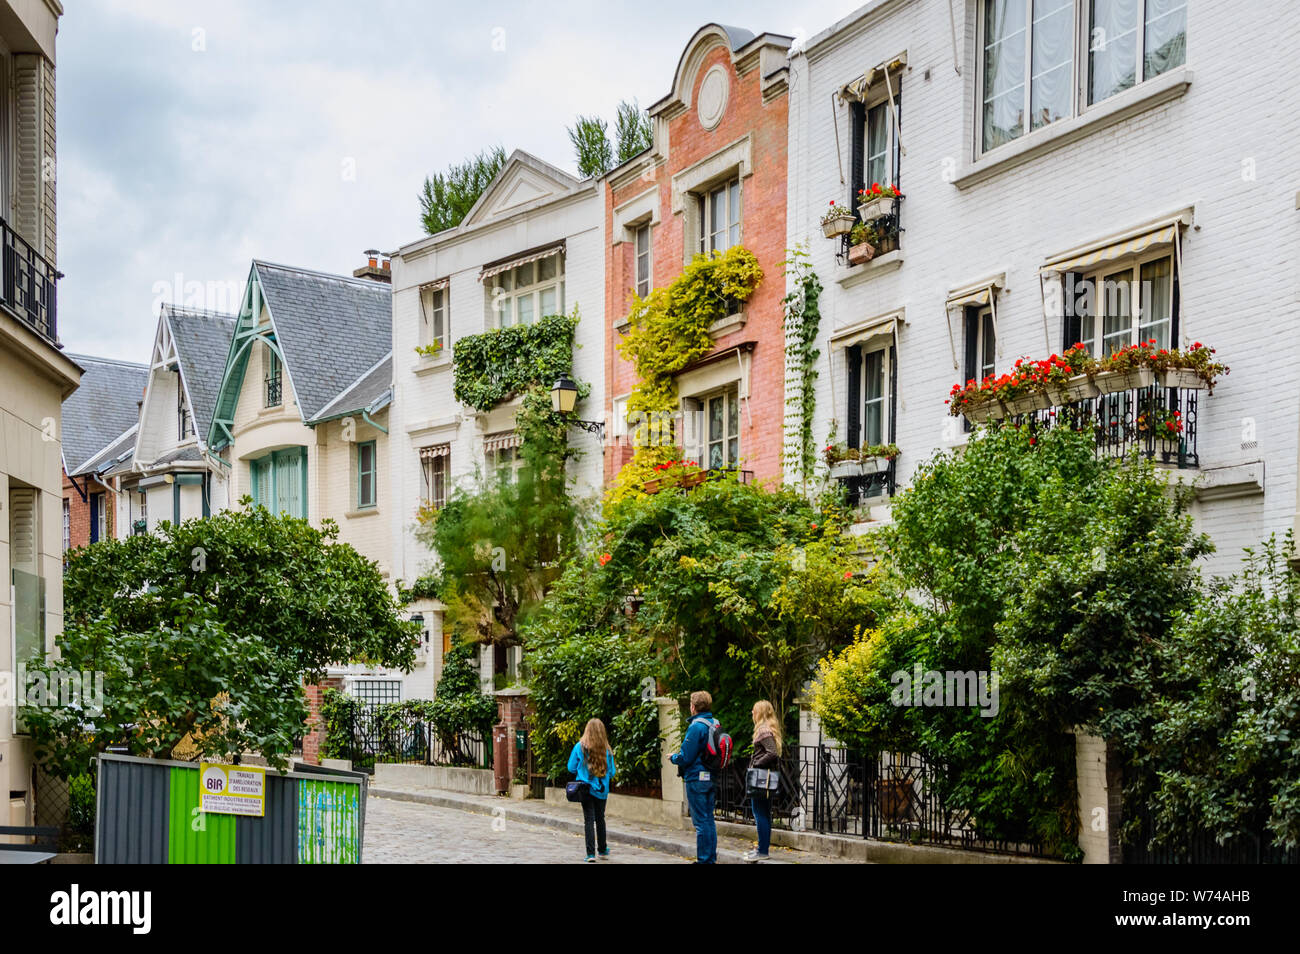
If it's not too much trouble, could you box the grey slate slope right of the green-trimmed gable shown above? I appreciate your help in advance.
[252,260,393,421]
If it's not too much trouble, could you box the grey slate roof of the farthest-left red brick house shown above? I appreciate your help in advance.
[62,355,150,476]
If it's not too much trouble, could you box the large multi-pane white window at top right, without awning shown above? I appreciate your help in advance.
[978,0,1187,152]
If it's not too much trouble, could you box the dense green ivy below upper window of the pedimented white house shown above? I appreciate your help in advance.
[451,308,579,411]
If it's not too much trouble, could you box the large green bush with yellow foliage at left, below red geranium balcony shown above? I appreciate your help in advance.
[815,426,1209,858]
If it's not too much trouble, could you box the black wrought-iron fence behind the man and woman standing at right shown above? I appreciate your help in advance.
[716,745,1043,855]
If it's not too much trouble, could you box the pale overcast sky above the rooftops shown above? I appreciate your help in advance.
[57,0,861,361]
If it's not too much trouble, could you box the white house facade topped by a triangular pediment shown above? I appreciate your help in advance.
[389,151,605,682]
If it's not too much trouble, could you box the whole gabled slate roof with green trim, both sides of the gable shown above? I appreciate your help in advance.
[208,260,393,448]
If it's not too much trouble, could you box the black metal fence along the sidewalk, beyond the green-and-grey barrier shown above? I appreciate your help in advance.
[341,706,491,775]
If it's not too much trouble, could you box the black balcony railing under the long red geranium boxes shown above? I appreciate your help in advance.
[1008,385,1200,468]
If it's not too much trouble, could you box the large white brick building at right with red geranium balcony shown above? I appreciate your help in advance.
[788,0,1300,572]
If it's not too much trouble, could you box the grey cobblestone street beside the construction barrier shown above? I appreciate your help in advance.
[361,798,686,864]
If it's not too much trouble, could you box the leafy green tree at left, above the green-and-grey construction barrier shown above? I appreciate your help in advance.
[23,509,417,772]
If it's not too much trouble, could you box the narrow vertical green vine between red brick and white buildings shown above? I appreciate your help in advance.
[781,246,822,489]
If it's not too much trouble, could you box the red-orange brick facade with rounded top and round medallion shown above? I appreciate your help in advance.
[605,25,789,482]
